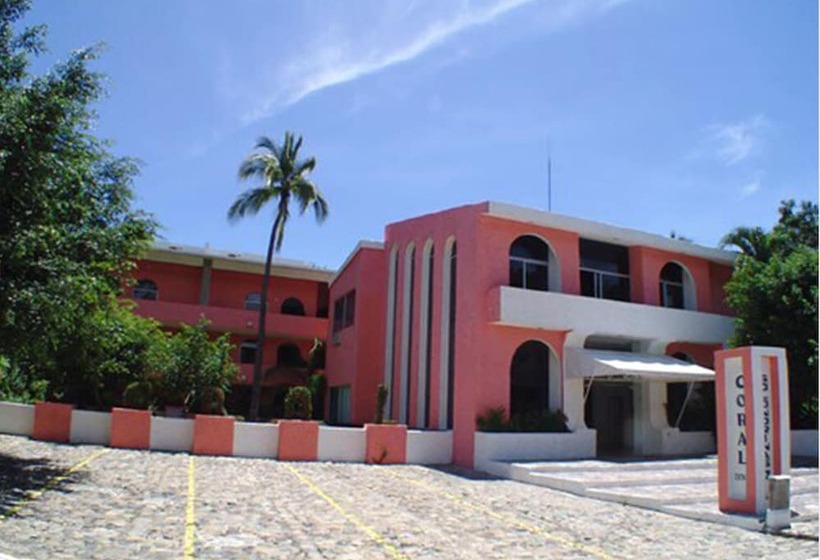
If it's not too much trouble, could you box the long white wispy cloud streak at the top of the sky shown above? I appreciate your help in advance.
[220,0,626,124]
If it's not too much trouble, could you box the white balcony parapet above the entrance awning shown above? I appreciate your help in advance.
[488,286,734,344]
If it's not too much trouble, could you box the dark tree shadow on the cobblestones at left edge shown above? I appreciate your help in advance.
[0,451,82,517]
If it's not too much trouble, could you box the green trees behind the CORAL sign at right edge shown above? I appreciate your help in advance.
[724,200,818,427]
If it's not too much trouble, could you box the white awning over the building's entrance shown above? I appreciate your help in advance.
[566,348,715,381]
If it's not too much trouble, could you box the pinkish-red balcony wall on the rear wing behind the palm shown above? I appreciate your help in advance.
[135,300,328,339]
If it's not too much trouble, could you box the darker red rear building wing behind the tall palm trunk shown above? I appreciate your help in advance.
[131,242,333,417]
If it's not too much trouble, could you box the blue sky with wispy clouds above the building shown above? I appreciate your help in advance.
[27,0,818,267]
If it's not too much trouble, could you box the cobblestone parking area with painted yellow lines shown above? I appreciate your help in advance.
[0,435,818,560]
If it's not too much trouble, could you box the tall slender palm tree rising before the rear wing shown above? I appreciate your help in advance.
[228,132,328,422]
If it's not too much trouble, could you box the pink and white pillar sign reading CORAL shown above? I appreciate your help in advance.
[715,346,791,517]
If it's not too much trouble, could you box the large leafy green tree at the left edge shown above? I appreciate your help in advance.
[0,0,156,397]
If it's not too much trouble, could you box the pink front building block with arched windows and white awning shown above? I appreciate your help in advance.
[327,202,735,466]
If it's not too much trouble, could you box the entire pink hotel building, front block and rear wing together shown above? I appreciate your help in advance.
[134,202,734,468]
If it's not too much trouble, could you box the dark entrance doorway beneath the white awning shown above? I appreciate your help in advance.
[584,380,634,456]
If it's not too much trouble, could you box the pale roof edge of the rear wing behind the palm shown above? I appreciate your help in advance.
[143,241,334,282]
